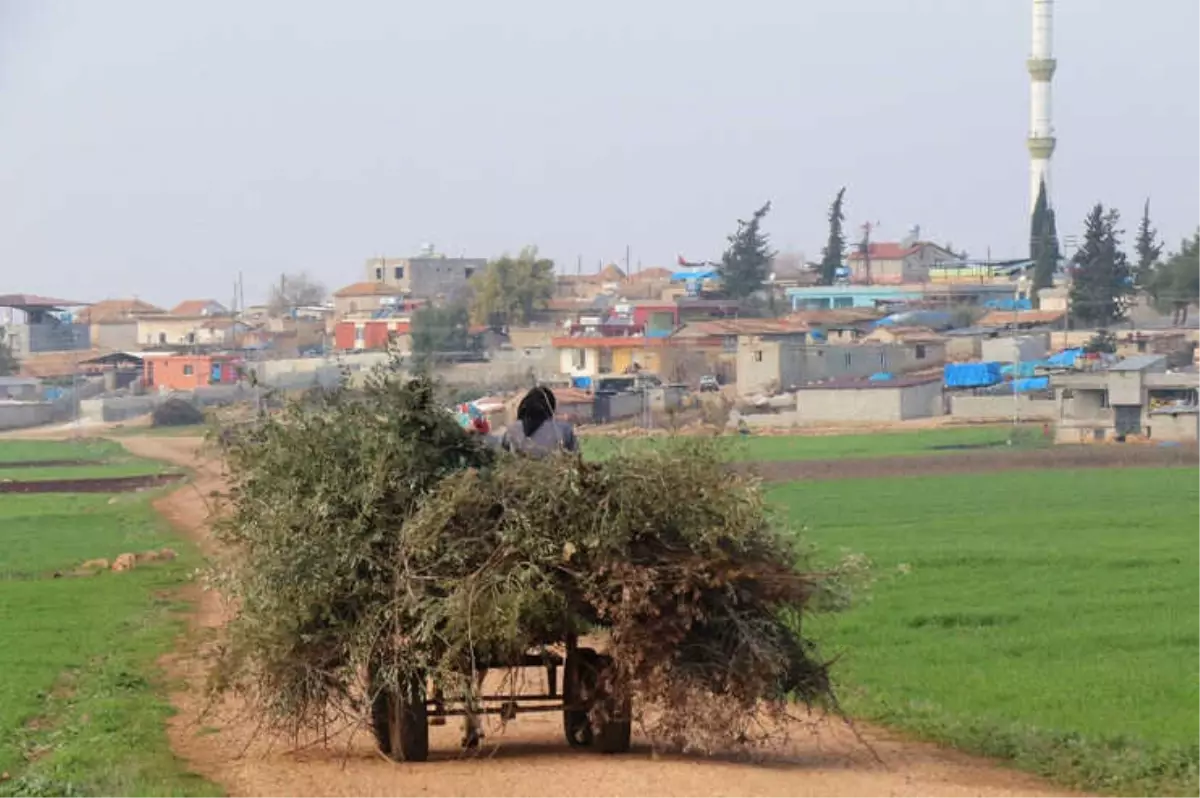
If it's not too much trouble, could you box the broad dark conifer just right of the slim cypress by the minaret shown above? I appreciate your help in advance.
[1070,208,1134,329]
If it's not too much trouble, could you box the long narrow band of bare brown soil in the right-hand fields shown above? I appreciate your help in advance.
[746,444,1200,482]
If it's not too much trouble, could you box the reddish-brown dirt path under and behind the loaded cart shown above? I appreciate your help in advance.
[121,438,1089,798]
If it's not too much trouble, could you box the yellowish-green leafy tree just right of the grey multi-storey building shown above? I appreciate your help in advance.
[470,246,554,326]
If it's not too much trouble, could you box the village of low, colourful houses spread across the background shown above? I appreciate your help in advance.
[0,230,1200,443]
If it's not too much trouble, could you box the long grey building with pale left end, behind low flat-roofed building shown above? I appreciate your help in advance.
[737,335,946,396]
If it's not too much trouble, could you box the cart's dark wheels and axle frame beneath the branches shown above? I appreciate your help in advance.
[371,636,632,762]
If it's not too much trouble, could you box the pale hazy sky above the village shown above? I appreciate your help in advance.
[0,0,1200,306]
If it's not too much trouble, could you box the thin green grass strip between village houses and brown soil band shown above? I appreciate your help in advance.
[582,425,1045,462]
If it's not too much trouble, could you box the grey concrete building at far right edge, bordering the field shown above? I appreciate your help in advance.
[1050,355,1200,443]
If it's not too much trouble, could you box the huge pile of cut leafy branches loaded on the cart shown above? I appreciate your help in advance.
[216,360,829,749]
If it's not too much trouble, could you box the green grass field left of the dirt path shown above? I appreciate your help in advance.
[0,442,217,796]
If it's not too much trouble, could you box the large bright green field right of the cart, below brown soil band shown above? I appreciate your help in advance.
[773,469,1200,796]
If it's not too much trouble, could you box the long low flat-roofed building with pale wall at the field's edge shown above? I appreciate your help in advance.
[796,377,944,424]
